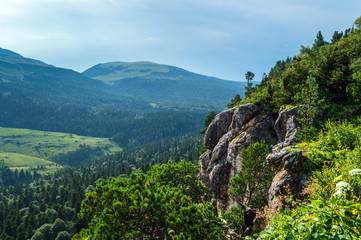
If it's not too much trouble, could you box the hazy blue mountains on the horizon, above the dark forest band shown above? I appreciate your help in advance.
[0,49,244,111]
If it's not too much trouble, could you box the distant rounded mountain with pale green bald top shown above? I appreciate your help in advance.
[82,61,246,105]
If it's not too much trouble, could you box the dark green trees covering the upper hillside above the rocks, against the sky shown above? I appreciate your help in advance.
[245,18,361,121]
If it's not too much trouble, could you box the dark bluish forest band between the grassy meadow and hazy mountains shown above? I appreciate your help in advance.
[0,91,206,147]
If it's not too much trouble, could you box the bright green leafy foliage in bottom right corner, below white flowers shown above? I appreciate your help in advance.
[260,198,361,240]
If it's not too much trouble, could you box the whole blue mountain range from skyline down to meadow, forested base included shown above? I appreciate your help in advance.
[0,49,245,147]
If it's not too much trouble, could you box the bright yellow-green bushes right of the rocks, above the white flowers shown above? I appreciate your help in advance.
[305,119,361,205]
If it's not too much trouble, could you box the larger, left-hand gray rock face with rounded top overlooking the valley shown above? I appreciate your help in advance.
[198,103,276,211]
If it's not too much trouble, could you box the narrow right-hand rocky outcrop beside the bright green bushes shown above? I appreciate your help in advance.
[266,107,309,209]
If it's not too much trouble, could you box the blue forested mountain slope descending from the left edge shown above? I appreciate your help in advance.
[0,49,135,106]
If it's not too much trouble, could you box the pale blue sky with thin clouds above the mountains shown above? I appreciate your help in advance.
[0,0,361,81]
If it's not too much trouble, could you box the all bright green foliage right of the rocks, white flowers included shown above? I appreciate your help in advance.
[260,119,361,239]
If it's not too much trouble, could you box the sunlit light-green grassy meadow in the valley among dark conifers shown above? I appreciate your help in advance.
[0,127,122,171]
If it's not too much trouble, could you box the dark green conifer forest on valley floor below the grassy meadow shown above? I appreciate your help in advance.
[0,135,201,239]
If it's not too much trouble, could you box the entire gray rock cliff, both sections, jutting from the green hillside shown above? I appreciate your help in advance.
[198,103,308,212]
